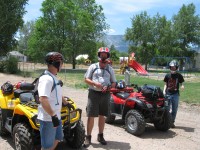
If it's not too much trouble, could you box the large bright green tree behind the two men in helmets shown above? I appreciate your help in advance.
[28,0,107,69]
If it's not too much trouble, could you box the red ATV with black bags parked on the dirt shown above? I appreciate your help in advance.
[106,84,172,136]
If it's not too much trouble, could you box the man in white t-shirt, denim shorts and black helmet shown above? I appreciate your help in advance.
[38,52,67,150]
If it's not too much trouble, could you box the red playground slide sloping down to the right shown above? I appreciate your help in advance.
[128,60,148,75]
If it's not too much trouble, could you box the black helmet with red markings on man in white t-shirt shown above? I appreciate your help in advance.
[45,52,64,70]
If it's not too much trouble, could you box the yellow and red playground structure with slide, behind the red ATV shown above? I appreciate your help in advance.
[120,53,148,75]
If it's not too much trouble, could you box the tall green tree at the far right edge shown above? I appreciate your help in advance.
[172,3,200,56]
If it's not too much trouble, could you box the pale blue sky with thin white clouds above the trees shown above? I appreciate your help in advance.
[24,0,200,35]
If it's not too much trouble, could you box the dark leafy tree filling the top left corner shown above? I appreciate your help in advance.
[0,0,28,55]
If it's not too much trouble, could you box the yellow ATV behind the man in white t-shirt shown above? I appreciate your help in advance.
[0,82,85,150]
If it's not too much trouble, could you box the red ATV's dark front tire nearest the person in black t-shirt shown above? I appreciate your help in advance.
[154,110,172,131]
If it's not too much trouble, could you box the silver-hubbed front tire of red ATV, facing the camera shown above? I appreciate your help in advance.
[125,110,146,136]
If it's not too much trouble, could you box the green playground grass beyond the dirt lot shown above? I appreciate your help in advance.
[22,69,200,104]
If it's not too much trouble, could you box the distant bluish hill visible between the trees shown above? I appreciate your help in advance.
[103,35,128,52]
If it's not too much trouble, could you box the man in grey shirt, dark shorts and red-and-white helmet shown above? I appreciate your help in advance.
[84,47,116,147]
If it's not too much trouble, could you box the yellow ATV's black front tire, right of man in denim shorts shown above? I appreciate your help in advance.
[64,120,85,149]
